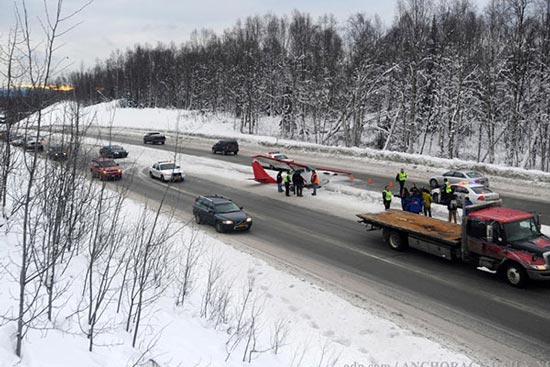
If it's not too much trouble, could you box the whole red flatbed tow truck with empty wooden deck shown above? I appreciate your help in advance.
[357,201,550,287]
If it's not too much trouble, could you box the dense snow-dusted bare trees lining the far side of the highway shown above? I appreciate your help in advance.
[67,0,550,171]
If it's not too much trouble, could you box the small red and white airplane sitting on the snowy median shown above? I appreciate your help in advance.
[251,154,353,187]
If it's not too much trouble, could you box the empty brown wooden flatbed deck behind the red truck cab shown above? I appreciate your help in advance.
[357,209,462,260]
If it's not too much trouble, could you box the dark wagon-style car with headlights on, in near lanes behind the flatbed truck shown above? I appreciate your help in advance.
[193,195,252,233]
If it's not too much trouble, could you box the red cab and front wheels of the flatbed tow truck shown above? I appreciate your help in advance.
[462,206,550,287]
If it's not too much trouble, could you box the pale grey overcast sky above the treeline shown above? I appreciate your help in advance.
[0,0,487,75]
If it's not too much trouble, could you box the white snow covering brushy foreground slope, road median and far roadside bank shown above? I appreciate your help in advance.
[0,102,548,367]
